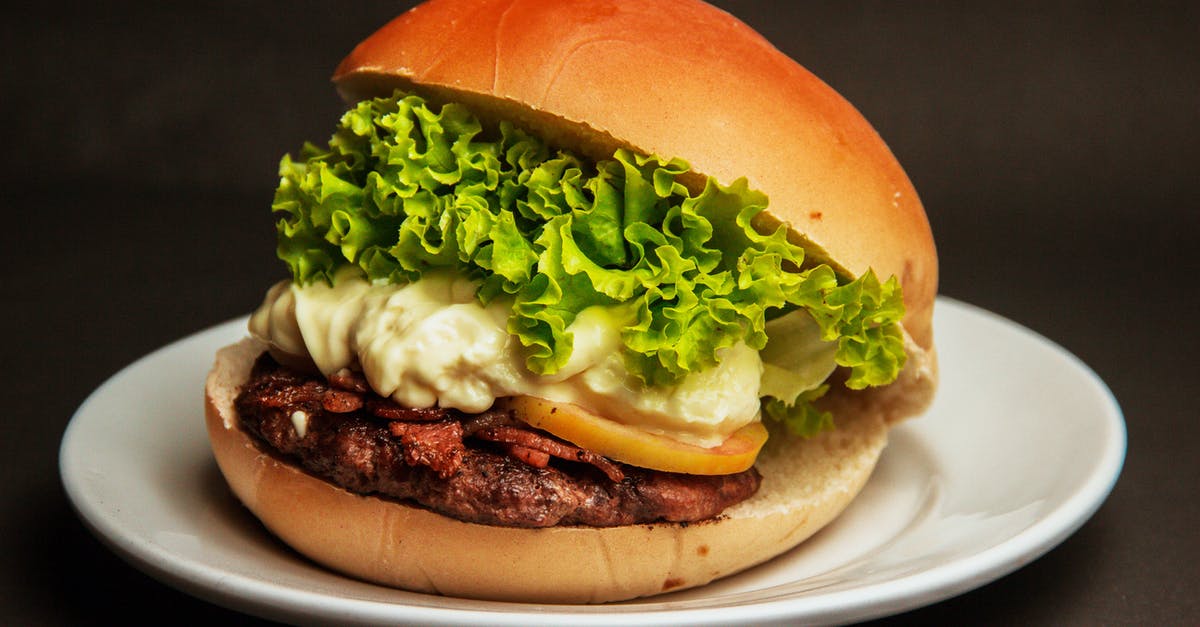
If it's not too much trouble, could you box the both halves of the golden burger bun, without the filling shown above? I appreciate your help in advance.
[205,0,937,603]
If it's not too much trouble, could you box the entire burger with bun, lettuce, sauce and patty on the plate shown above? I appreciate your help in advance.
[205,0,937,603]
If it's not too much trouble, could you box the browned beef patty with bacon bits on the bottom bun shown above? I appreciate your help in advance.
[236,353,761,527]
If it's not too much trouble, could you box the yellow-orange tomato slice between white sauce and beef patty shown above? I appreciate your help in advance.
[502,396,767,474]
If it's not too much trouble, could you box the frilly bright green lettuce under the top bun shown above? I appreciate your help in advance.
[272,91,905,432]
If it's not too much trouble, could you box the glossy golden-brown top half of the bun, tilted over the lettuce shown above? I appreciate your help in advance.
[334,0,937,420]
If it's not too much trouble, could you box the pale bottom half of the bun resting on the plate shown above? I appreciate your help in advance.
[205,340,887,603]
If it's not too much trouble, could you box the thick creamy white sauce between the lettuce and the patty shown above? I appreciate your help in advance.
[250,267,763,447]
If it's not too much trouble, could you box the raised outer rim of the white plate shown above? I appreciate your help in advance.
[59,295,1128,625]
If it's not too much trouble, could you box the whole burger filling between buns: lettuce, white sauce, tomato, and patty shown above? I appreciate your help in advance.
[244,91,905,526]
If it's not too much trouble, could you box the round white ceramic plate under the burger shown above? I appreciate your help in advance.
[60,298,1126,626]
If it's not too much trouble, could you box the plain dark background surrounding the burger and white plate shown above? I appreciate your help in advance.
[0,0,1200,625]
